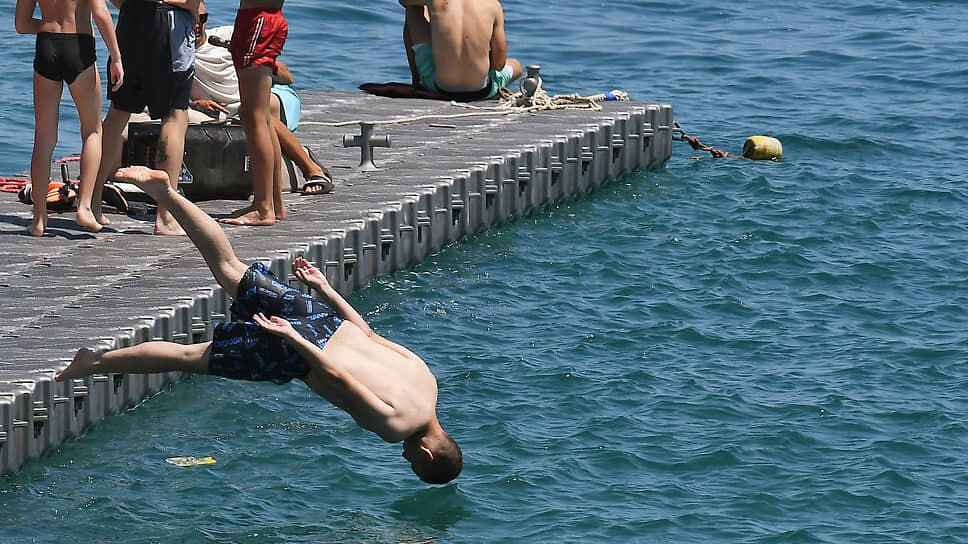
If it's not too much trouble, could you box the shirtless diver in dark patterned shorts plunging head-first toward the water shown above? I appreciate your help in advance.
[57,166,462,484]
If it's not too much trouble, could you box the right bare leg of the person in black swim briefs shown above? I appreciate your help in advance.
[67,65,101,232]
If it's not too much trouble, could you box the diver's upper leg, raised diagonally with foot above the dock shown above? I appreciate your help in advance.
[115,166,248,298]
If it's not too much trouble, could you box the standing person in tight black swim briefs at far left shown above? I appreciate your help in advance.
[15,0,124,236]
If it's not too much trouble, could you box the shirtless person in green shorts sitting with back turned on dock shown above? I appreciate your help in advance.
[399,0,522,102]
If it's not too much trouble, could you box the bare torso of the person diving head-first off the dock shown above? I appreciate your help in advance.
[304,321,437,442]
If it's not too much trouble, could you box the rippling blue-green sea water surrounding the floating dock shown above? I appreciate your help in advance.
[0,0,968,543]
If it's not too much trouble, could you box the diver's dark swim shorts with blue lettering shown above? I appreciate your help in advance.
[208,262,343,384]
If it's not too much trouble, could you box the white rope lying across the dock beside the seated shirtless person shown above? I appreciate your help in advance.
[299,84,629,127]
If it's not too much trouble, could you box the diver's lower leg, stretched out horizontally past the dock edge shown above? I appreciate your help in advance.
[55,342,212,381]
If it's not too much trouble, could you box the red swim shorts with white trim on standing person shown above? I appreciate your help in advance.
[229,8,289,74]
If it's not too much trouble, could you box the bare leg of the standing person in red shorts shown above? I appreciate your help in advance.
[228,66,284,226]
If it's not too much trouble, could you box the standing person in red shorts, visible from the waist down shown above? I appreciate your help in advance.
[222,0,289,226]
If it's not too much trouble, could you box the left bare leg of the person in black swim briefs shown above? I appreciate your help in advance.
[27,72,64,236]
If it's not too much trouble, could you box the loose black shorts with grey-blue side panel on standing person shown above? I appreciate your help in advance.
[107,0,195,119]
